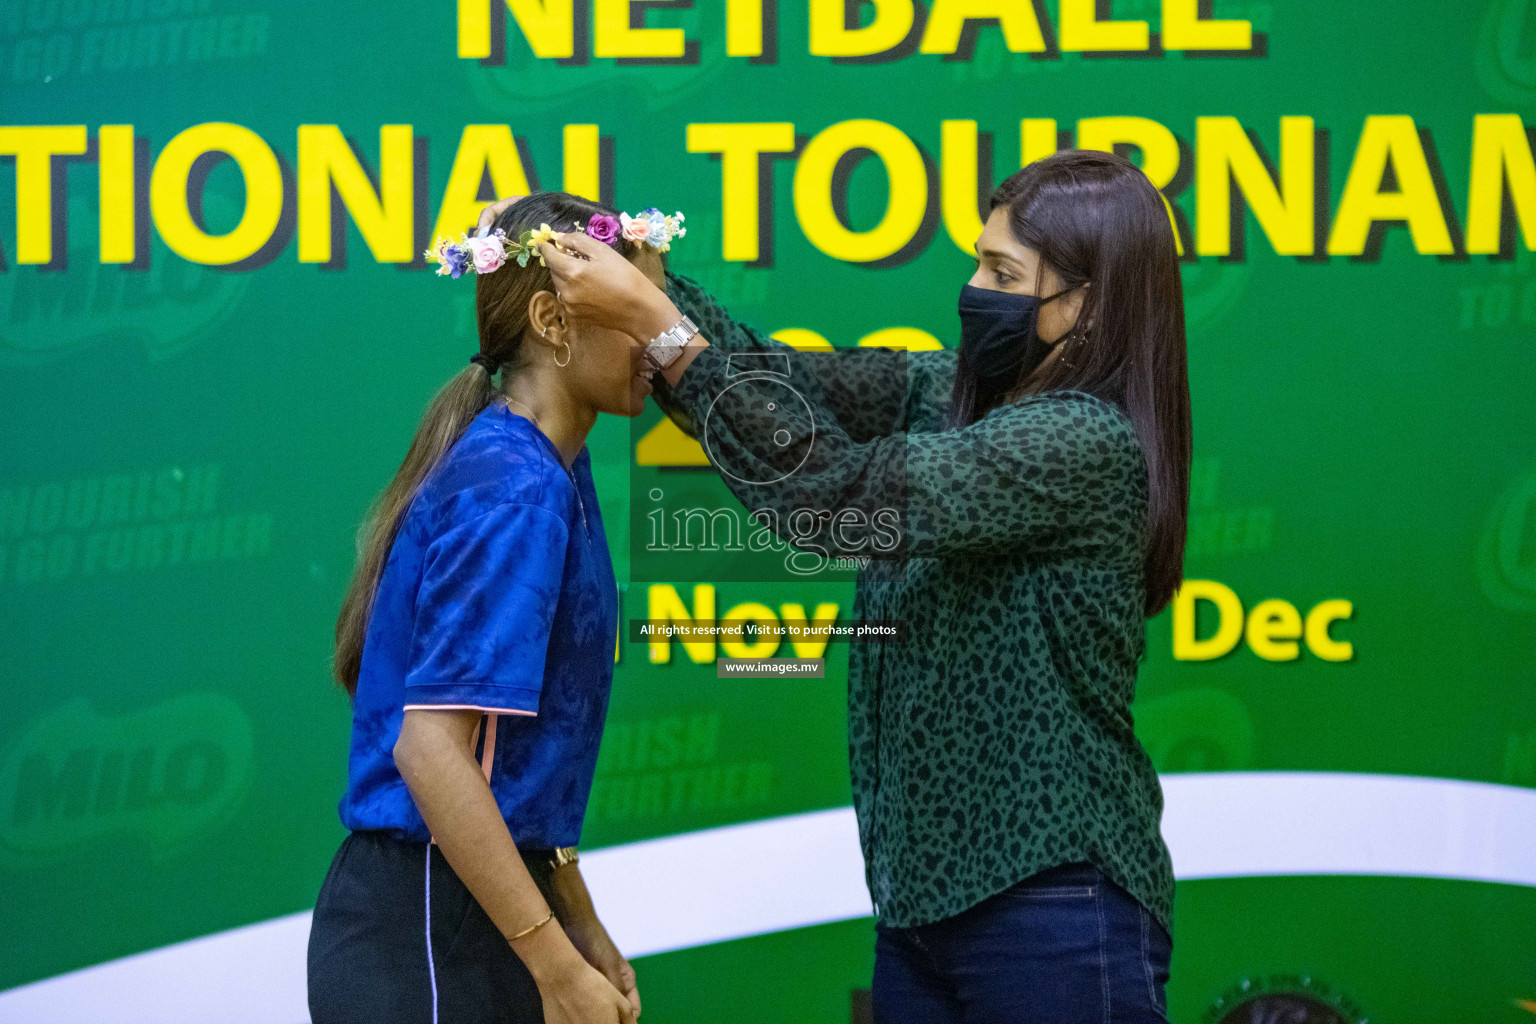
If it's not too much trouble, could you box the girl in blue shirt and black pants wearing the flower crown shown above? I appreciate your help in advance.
[309,193,684,1024]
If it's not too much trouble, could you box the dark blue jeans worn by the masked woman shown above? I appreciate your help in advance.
[872,864,1174,1024]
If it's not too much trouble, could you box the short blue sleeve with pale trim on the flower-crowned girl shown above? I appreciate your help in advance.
[406,502,567,715]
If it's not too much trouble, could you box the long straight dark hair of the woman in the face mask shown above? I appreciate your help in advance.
[951,149,1192,616]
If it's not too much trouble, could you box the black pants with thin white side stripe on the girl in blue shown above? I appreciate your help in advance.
[309,832,544,1024]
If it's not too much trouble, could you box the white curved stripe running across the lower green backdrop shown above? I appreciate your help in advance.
[0,772,1536,1024]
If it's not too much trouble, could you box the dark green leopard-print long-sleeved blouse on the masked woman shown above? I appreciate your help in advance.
[656,275,1174,927]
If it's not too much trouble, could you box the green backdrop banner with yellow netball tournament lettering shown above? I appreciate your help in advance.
[0,0,1536,1024]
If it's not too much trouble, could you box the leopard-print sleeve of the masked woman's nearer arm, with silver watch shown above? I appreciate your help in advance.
[673,347,1146,557]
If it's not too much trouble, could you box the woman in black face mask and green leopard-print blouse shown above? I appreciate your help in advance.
[525,152,1190,1024]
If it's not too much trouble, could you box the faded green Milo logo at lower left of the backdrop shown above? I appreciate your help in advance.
[0,694,252,855]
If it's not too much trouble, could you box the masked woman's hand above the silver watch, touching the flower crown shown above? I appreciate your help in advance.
[539,232,682,344]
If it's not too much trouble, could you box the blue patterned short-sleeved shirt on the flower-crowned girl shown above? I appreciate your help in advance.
[341,401,619,847]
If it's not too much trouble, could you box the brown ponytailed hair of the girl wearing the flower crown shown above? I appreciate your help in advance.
[332,192,639,694]
